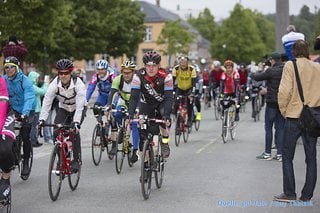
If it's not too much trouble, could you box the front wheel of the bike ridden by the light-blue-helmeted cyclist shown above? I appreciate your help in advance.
[91,124,102,166]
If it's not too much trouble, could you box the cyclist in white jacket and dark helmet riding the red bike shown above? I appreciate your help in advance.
[39,59,87,172]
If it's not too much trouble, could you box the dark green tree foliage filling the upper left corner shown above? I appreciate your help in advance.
[0,0,144,70]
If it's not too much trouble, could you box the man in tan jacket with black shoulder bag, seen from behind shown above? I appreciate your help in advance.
[274,40,320,202]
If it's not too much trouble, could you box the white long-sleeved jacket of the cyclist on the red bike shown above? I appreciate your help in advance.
[39,76,87,123]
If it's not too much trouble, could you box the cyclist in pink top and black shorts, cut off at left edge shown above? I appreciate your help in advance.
[0,77,16,201]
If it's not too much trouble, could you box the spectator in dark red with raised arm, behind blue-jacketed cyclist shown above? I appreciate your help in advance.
[2,35,28,74]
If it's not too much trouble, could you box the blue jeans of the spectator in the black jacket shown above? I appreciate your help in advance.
[264,104,285,155]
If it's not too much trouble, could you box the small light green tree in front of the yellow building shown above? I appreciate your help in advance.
[157,20,194,65]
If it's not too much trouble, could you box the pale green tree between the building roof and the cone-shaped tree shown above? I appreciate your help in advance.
[188,8,217,41]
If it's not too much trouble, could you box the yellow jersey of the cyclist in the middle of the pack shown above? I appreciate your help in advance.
[172,65,197,90]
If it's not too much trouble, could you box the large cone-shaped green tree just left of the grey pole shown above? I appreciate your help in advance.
[211,4,266,62]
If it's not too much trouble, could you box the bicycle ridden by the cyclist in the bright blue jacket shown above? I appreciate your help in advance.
[12,116,33,180]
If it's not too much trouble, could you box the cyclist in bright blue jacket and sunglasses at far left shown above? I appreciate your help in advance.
[4,56,36,175]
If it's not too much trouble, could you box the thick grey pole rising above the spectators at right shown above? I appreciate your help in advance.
[275,0,290,53]
